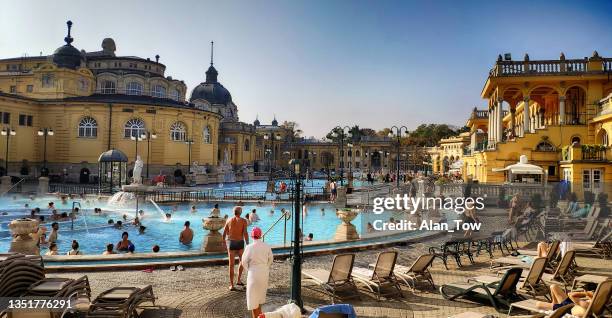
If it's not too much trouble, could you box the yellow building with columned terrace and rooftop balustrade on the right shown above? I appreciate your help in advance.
[462,52,612,196]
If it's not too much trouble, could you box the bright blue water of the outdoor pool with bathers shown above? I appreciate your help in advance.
[0,196,416,255]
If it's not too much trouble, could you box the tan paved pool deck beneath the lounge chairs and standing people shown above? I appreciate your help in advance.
[46,211,612,318]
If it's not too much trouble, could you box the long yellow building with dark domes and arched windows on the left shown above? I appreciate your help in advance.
[0,22,256,182]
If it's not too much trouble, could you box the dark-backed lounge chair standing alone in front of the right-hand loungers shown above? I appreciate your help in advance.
[440,267,524,311]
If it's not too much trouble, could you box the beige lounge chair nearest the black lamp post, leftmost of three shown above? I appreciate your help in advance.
[302,254,359,303]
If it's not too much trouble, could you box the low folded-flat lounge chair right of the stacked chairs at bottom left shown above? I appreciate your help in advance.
[87,285,155,318]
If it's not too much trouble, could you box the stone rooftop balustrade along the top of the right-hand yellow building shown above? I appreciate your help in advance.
[489,52,612,77]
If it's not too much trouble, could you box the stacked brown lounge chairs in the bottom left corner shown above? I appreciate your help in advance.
[0,254,155,318]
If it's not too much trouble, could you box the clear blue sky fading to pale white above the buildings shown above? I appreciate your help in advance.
[0,0,612,137]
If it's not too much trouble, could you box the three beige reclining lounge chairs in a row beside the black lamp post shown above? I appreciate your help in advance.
[302,251,435,303]
